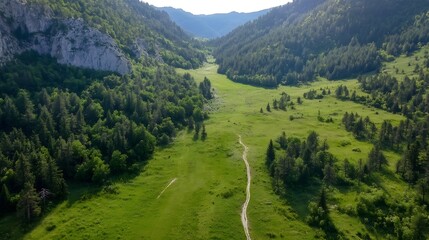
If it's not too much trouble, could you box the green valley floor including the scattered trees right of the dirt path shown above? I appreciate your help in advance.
[0,46,429,240]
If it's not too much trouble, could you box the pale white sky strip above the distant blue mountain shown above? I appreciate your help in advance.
[142,0,292,14]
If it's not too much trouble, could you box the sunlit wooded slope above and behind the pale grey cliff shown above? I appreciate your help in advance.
[30,0,205,69]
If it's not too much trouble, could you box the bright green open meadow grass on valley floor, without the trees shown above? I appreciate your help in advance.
[0,50,422,239]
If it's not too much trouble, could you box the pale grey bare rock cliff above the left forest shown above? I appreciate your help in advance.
[0,0,131,74]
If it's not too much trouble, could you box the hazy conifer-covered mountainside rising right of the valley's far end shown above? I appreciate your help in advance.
[213,0,429,87]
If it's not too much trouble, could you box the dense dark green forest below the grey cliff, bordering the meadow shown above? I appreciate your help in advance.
[0,55,207,220]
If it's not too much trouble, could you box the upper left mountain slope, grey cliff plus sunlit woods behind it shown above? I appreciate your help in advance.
[0,0,204,74]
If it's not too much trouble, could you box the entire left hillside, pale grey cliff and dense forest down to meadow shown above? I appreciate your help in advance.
[0,0,210,225]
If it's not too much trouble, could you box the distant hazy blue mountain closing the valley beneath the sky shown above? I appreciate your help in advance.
[160,7,269,39]
